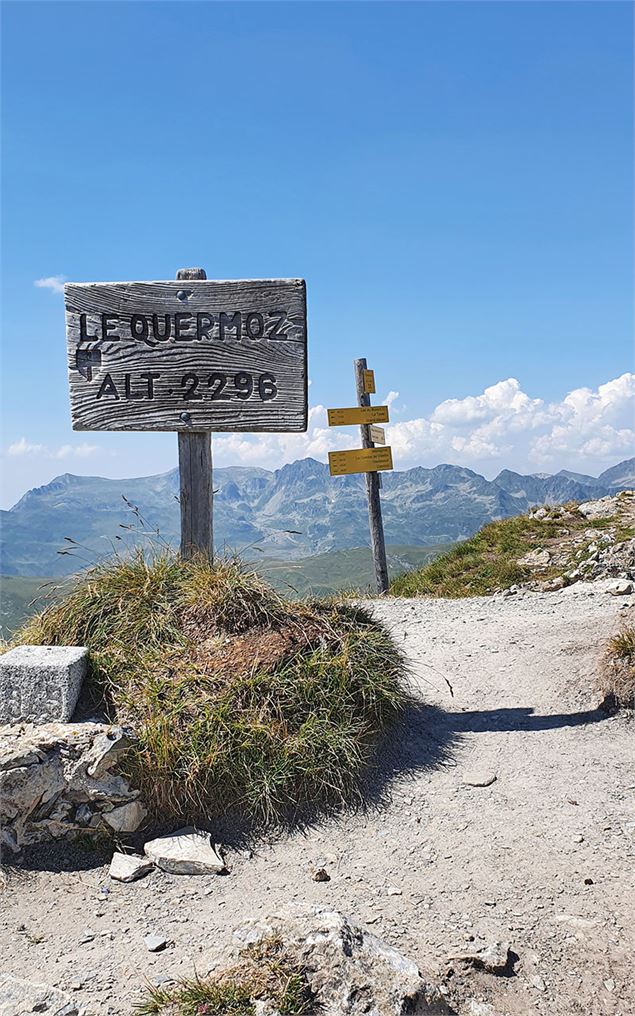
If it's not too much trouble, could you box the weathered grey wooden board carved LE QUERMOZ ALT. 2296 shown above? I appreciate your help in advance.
[64,273,307,432]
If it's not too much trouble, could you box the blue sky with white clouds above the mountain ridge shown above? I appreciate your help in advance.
[2,0,633,505]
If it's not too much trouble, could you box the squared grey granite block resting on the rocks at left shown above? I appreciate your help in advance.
[0,645,88,723]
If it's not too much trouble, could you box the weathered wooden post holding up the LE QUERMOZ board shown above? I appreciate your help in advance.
[177,268,213,562]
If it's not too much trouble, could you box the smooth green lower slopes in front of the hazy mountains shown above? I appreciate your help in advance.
[0,544,447,639]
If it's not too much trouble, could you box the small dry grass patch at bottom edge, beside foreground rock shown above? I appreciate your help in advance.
[137,938,318,1016]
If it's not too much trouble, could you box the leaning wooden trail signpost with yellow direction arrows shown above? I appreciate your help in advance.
[328,360,392,592]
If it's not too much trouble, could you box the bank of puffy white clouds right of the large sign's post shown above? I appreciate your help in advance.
[214,374,635,475]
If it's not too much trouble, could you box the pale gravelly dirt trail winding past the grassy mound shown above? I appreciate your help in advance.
[0,583,635,1016]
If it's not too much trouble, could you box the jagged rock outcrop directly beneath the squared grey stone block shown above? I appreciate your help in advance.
[0,722,146,851]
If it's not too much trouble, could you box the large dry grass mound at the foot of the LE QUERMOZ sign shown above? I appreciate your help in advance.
[17,554,405,822]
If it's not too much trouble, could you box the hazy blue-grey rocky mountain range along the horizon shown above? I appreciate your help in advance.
[0,458,635,576]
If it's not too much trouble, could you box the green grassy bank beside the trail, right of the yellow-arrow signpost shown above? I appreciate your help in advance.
[390,515,563,597]
